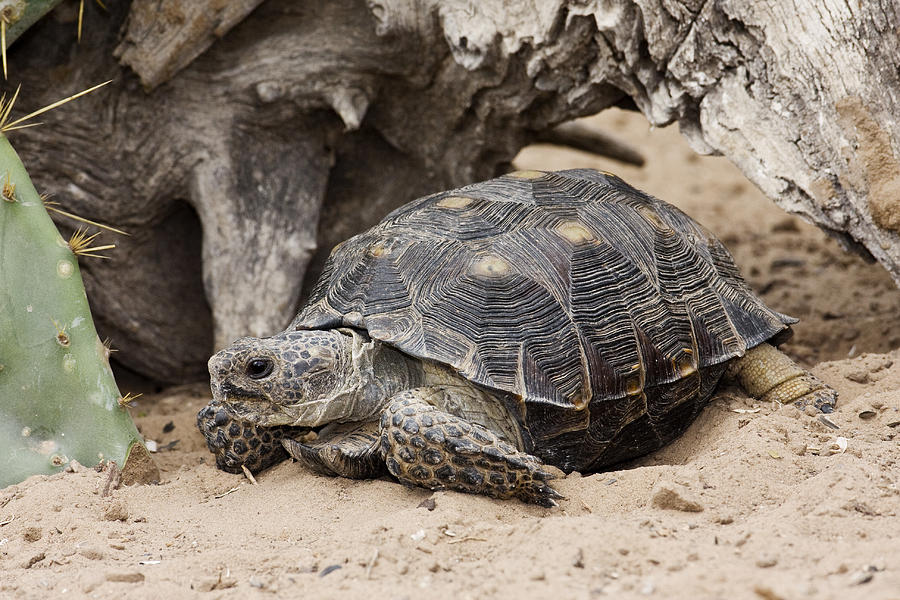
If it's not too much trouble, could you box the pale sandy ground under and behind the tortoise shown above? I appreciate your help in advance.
[0,111,900,600]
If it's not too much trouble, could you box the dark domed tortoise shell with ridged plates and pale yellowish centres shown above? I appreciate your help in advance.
[291,169,795,468]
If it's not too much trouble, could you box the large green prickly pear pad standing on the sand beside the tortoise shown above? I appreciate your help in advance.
[0,134,147,488]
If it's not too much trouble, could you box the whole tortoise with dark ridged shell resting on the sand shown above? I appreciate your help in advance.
[198,169,837,506]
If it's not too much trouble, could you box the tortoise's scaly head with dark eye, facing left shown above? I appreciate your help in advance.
[209,330,360,427]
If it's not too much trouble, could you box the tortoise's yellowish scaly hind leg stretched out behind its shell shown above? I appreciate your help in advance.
[729,344,837,413]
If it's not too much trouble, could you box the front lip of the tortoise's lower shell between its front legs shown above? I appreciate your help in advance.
[281,422,385,479]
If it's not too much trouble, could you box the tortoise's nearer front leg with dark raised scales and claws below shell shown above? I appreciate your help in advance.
[381,390,562,507]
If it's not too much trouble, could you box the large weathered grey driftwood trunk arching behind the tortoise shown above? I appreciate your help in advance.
[11,0,900,381]
